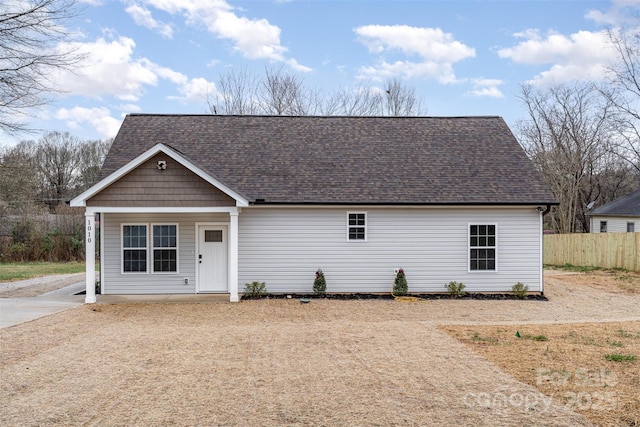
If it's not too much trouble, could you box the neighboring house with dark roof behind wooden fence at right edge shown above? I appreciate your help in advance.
[588,190,640,233]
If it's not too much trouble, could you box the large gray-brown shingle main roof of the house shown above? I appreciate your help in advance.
[101,114,555,204]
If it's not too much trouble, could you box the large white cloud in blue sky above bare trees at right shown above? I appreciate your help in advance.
[498,30,615,85]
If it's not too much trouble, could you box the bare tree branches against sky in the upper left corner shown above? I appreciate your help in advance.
[0,0,79,133]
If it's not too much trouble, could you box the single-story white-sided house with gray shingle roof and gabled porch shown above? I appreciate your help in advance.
[71,114,557,302]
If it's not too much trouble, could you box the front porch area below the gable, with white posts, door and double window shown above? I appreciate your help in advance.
[80,207,240,304]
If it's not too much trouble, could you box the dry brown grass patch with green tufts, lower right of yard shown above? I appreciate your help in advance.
[441,321,640,426]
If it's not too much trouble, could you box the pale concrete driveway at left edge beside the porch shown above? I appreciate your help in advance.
[0,275,85,328]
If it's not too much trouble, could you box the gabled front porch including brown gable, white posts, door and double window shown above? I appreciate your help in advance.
[70,144,248,304]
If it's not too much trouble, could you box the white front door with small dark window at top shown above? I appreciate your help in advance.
[197,225,228,292]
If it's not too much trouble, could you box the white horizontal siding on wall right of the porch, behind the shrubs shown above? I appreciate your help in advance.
[239,207,542,292]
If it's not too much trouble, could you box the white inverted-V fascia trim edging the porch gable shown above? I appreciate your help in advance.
[69,144,249,208]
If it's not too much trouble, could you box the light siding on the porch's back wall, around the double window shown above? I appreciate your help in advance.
[101,214,229,294]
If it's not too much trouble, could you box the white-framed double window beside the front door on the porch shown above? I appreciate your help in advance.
[122,224,178,273]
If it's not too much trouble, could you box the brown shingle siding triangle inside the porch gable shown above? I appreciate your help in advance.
[87,154,235,207]
